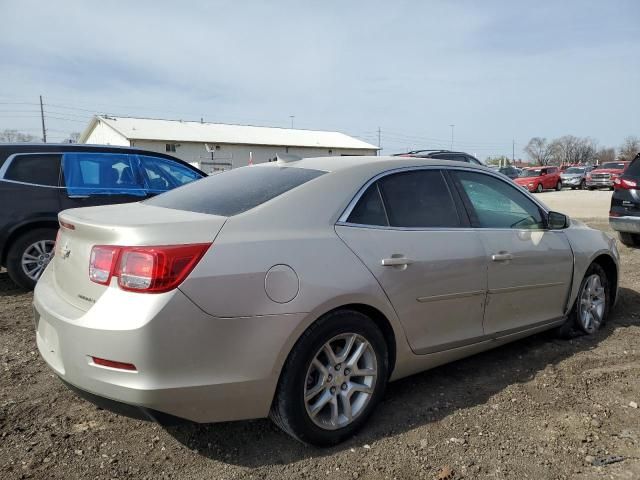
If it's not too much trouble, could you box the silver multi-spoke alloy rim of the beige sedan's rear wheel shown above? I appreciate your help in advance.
[304,333,378,430]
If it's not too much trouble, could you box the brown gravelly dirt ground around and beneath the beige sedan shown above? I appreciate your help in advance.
[0,192,640,480]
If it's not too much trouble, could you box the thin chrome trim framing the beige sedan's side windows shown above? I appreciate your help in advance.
[336,165,554,232]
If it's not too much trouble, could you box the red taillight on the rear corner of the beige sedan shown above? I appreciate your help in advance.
[89,243,211,293]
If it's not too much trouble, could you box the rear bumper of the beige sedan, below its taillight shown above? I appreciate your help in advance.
[34,268,303,422]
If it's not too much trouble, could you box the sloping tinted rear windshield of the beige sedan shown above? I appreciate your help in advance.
[144,166,326,217]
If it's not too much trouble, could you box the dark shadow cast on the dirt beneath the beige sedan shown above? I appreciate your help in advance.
[167,288,640,467]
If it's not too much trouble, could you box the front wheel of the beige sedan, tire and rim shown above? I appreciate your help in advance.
[558,263,611,338]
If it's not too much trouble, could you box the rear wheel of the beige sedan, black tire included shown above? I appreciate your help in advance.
[270,310,389,446]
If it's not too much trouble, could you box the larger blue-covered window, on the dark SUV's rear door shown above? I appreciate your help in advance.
[62,152,146,197]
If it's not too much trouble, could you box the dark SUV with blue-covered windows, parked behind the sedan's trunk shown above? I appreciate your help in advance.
[0,144,206,288]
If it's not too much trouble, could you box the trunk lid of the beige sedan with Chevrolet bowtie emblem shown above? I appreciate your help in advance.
[52,203,227,311]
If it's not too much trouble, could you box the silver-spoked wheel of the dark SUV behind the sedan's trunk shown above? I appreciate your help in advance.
[7,228,56,290]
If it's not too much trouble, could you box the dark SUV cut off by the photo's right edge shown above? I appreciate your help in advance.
[609,153,640,247]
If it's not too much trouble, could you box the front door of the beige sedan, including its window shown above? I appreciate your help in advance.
[452,170,573,335]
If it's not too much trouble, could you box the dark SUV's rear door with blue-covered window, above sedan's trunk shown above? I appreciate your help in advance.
[60,152,147,210]
